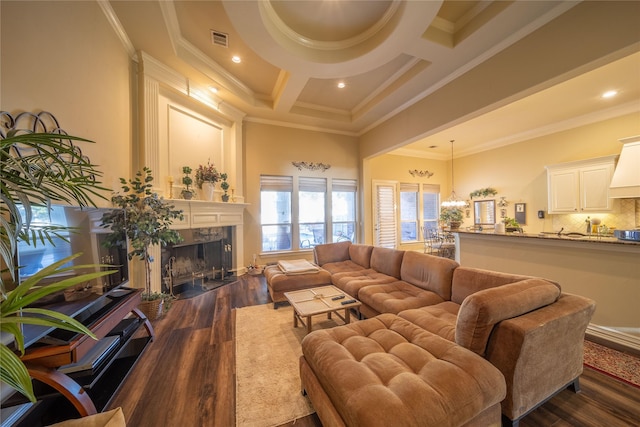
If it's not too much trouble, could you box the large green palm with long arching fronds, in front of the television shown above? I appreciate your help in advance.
[0,130,112,402]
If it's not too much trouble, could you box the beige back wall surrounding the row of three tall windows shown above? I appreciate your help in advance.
[244,122,358,264]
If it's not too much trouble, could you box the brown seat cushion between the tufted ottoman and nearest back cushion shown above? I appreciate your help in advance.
[398,301,460,341]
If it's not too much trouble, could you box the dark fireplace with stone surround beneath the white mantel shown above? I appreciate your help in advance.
[162,227,236,295]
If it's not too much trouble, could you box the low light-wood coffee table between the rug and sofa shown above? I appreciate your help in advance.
[284,286,362,333]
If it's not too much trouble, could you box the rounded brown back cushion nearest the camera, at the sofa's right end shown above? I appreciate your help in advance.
[456,279,560,356]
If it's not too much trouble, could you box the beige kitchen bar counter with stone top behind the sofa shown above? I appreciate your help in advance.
[455,231,640,350]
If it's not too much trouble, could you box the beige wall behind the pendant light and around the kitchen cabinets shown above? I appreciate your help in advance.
[364,113,640,242]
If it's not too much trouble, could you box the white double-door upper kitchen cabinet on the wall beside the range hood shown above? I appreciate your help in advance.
[546,156,617,214]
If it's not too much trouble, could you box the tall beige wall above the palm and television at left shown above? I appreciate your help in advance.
[0,1,135,206]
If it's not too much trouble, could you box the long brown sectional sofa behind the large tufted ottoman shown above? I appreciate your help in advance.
[303,242,595,425]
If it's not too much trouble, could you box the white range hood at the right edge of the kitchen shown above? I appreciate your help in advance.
[609,135,640,199]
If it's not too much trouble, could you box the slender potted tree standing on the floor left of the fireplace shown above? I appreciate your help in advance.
[102,167,183,320]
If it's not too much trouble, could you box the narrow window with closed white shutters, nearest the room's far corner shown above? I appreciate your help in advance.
[374,183,397,248]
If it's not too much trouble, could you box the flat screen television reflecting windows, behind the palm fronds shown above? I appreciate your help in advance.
[9,205,129,291]
